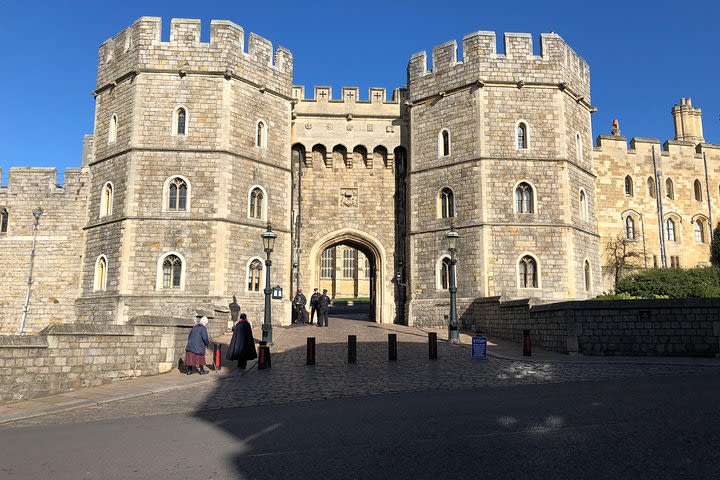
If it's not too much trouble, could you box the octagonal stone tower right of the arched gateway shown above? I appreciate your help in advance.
[408,32,600,325]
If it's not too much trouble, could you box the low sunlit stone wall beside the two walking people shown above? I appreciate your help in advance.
[0,315,227,403]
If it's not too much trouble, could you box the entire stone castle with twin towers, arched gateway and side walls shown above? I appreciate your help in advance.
[0,17,720,334]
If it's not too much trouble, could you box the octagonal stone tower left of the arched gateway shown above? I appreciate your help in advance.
[76,17,293,323]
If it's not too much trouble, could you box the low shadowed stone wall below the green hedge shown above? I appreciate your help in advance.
[461,297,720,356]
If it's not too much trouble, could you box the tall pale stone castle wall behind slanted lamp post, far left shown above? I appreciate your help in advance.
[0,168,89,334]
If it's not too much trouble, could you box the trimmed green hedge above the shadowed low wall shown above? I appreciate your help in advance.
[615,267,720,298]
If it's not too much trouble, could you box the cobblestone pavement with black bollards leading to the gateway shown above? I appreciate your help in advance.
[5,318,720,428]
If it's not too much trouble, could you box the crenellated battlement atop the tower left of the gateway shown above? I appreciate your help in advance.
[97,17,293,96]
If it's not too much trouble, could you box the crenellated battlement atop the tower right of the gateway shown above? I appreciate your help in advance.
[407,31,590,103]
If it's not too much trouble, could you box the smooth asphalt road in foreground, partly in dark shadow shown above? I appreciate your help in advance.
[0,375,720,480]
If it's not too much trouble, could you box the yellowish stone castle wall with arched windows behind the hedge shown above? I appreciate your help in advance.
[593,135,720,291]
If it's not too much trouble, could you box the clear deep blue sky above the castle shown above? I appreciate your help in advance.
[0,0,720,184]
